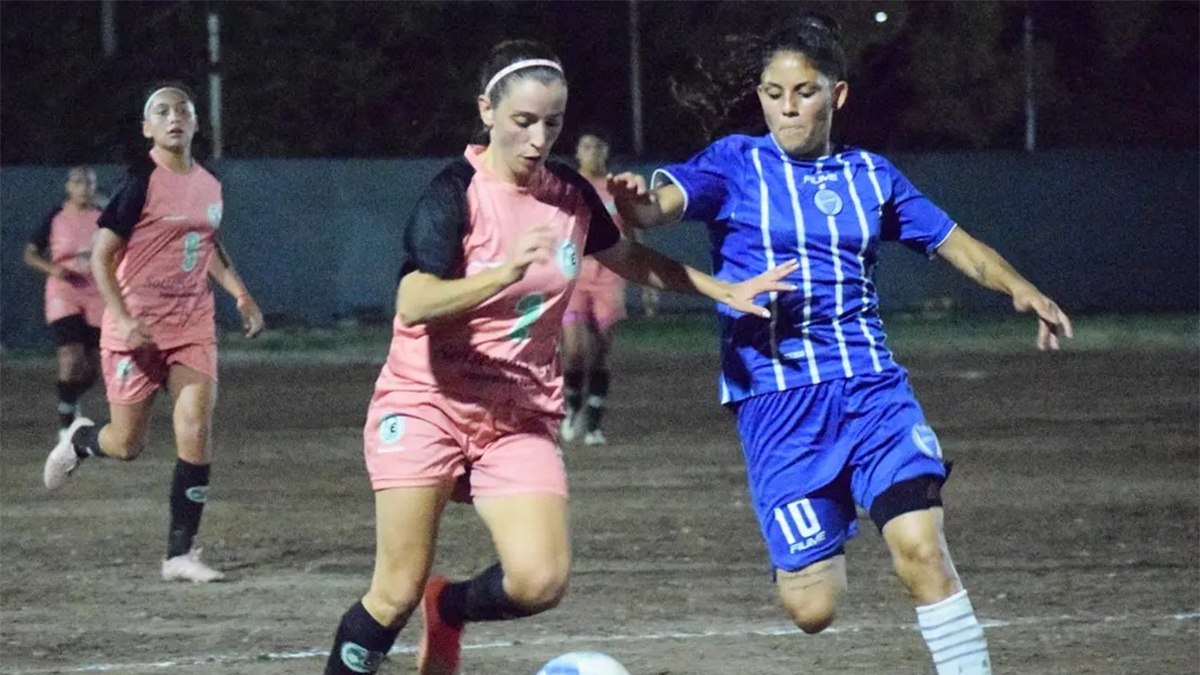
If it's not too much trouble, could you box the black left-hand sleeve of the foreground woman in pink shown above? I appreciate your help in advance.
[400,159,475,279]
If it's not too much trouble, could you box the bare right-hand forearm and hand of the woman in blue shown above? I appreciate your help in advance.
[937,227,1074,350]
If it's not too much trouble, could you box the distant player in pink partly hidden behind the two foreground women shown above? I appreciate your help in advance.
[560,132,625,446]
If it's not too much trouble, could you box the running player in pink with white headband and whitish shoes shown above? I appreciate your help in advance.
[44,86,263,581]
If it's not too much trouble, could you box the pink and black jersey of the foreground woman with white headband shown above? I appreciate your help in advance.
[376,145,620,417]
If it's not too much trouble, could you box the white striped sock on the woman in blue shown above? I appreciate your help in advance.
[917,590,991,675]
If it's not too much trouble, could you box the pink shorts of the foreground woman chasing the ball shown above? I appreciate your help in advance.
[362,389,566,501]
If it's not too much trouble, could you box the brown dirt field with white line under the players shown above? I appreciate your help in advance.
[0,321,1200,675]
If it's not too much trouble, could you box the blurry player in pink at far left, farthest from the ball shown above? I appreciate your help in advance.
[24,167,104,441]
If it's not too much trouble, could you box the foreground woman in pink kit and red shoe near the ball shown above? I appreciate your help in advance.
[325,41,798,675]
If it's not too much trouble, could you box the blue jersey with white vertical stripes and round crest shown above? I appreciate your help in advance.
[652,133,955,404]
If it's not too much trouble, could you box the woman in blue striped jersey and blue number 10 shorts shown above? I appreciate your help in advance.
[611,16,1072,675]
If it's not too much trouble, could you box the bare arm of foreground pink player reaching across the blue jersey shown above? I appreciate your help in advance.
[595,238,799,318]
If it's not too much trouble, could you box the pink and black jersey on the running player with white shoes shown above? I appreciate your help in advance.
[100,156,222,351]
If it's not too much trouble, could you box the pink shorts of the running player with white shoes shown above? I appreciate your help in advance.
[100,342,217,405]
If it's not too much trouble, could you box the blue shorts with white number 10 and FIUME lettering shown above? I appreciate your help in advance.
[737,368,946,572]
